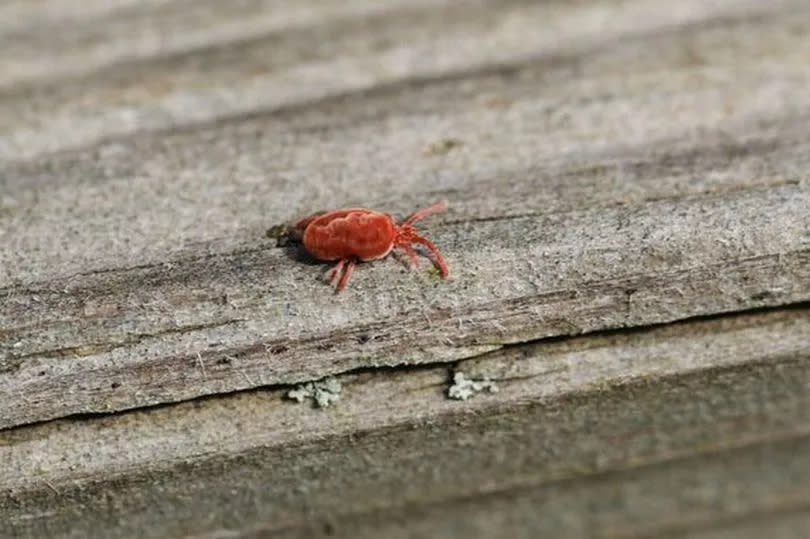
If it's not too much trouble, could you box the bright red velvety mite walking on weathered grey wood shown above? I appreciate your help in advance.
[294,200,450,292]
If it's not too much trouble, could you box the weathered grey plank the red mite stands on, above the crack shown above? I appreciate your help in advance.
[0,0,810,426]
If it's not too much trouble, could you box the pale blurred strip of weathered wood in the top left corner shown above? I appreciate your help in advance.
[0,0,422,86]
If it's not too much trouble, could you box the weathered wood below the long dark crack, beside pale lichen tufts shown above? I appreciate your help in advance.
[0,308,810,537]
